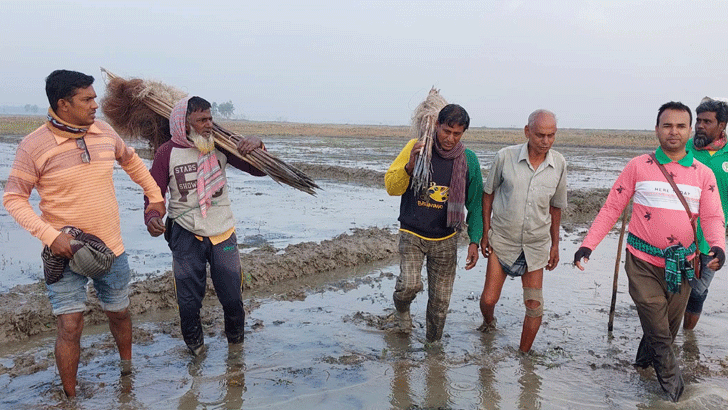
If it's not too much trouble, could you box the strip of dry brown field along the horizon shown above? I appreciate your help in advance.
[0,115,657,148]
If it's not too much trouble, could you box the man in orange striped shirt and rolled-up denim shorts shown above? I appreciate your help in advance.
[3,70,165,397]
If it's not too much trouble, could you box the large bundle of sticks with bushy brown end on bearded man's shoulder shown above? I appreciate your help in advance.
[101,67,320,195]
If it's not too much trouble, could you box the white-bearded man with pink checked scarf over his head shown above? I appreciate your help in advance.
[146,97,265,355]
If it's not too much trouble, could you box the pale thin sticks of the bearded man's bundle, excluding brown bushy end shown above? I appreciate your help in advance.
[101,67,320,196]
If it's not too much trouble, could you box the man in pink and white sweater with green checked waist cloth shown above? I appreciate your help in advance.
[574,101,725,401]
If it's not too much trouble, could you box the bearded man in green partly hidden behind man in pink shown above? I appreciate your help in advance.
[683,98,728,330]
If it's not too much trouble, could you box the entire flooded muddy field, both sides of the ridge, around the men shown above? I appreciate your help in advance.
[0,123,728,409]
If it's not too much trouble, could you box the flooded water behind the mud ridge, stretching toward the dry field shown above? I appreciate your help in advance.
[0,136,640,292]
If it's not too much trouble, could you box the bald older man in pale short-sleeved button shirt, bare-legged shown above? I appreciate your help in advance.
[479,110,566,353]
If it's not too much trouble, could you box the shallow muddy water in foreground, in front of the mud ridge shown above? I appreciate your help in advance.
[0,235,728,409]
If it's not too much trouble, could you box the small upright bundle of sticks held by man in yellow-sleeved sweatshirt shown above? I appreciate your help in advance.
[412,87,447,195]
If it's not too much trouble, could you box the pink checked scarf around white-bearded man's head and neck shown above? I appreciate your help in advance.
[169,97,225,218]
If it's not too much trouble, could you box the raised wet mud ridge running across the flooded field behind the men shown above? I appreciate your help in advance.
[0,186,608,344]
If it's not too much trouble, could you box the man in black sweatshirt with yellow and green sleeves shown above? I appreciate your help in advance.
[384,104,483,343]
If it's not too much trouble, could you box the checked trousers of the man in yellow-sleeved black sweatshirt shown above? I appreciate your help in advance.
[394,232,457,342]
